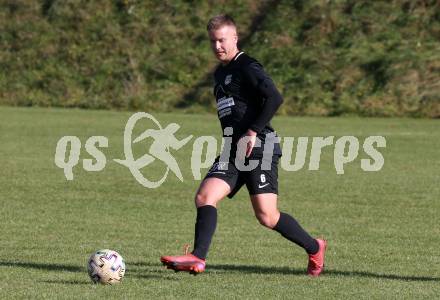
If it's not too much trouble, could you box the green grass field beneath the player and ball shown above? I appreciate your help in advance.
[0,107,440,299]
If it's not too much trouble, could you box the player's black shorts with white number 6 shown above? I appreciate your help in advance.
[205,155,280,198]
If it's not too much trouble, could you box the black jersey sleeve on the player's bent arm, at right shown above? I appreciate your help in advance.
[244,62,283,133]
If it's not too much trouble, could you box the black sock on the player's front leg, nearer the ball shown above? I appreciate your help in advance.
[192,205,217,259]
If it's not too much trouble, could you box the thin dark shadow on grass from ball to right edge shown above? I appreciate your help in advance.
[131,262,440,282]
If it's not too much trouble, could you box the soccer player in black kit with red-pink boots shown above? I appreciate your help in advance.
[160,15,326,276]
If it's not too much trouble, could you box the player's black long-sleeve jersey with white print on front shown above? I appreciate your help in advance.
[214,52,283,157]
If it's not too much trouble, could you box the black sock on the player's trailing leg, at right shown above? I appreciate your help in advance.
[273,213,319,254]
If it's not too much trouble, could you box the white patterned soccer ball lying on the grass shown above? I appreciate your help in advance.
[87,249,125,284]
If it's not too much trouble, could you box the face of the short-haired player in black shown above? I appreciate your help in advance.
[209,25,238,64]
